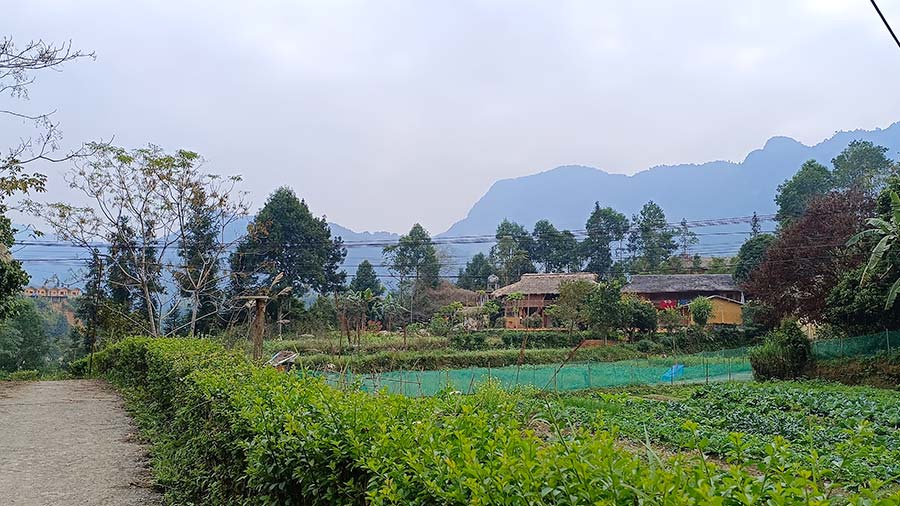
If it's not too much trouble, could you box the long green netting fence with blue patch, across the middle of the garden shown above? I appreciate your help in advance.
[312,357,750,396]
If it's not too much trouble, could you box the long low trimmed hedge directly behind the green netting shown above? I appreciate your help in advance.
[296,344,643,373]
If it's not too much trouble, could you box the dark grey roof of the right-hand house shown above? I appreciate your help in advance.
[622,274,744,308]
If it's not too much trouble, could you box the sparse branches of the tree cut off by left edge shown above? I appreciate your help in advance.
[0,37,93,320]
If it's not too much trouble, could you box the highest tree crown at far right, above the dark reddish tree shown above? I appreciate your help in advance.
[831,140,893,195]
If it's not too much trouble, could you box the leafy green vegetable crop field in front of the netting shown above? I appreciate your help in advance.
[558,383,900,486]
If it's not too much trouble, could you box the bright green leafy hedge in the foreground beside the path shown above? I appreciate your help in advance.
[81,339,900,505]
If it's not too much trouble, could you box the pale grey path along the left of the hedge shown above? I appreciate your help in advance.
[0,380,160,506]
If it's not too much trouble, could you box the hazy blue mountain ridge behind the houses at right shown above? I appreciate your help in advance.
[440,122,900,237]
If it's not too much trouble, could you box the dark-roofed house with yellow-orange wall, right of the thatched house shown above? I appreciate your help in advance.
[622,274,744,325]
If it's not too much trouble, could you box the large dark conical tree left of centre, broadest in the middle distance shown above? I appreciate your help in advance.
[230,186,347,321]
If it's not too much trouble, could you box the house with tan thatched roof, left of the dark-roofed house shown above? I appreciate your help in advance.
[491,272,597,329]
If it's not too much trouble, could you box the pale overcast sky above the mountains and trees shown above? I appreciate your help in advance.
[0,0,900,233]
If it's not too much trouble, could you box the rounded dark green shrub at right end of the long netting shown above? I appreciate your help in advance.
[749,320,812,380]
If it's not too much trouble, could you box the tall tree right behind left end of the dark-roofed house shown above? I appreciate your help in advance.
[628,200,678,272]
